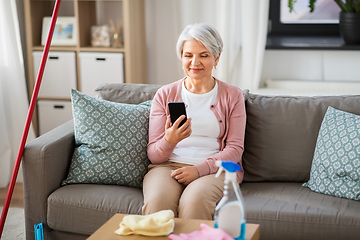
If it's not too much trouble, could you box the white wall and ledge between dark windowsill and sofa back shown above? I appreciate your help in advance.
[257,50,360,96]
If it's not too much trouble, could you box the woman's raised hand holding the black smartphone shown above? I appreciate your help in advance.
[165,115,191,144]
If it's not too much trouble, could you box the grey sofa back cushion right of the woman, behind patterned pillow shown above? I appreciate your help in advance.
[243,94,360,182]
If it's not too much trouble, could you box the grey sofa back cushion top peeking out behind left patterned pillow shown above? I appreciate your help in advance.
[95,83,162,104]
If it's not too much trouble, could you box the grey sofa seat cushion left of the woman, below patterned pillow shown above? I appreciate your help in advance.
[47,184,144,235]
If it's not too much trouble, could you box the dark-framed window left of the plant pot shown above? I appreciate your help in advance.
[269,0,340,36]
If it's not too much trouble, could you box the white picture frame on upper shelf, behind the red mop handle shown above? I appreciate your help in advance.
[41,17,77,46]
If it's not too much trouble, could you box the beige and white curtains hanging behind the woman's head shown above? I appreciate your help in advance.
[146,0,269,91]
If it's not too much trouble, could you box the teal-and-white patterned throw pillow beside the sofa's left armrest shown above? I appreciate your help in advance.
[62,89,151,188]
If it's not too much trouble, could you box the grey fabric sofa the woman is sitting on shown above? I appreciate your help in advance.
[22,84,360,240]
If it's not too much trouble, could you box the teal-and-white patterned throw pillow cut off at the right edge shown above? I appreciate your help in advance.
[303,107,360,200]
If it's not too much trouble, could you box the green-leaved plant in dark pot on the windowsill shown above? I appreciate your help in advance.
[288,0,360,45]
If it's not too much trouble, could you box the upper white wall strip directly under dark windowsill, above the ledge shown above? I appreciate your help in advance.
[261,50,360,82]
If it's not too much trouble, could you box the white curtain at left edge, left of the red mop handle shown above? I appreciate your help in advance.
[0,0,35,187]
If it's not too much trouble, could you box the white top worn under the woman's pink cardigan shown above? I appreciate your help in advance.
[169,81,220,165]
